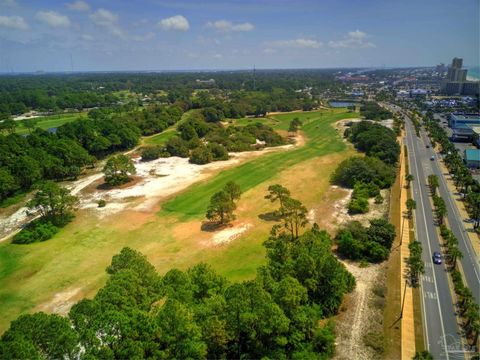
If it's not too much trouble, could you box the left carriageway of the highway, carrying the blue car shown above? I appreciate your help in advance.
[405,118,464,359]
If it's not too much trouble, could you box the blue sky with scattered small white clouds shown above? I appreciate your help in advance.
[0,0,480,72]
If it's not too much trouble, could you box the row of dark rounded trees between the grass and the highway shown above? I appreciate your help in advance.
[331,121,400,262]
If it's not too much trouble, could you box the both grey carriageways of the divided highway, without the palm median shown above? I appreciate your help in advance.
[380,105,474,360]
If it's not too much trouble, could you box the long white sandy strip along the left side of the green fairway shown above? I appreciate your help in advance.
[0,140,302,242]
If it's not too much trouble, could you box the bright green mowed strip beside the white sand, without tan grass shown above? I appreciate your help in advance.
[159,109,358,220]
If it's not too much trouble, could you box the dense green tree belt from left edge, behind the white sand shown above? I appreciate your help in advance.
[0,106,182,201]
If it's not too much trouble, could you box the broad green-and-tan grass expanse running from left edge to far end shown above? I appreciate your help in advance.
[0,110,358,333]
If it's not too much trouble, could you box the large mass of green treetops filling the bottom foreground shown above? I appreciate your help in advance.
[0,222,355,359]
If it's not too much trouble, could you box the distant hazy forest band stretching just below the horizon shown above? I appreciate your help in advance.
[0,70,345,119]
